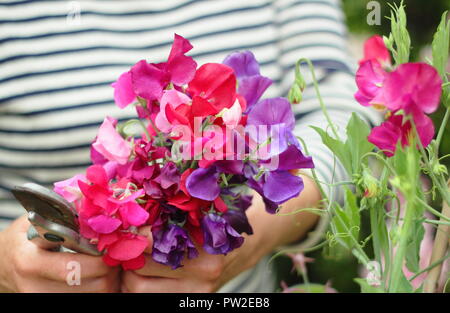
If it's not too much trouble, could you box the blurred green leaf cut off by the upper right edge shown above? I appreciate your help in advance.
[431,11,450,79]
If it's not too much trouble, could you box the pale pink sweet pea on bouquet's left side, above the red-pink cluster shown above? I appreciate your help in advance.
[92,117,131,164]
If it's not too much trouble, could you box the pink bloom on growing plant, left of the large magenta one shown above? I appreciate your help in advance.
[355,59,388,109]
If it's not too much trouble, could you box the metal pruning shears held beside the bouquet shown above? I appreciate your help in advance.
[11,183,101,256]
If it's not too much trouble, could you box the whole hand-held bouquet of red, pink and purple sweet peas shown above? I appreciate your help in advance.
[51,35,314,270]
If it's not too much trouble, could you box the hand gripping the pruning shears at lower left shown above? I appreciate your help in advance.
[0,216,120,292]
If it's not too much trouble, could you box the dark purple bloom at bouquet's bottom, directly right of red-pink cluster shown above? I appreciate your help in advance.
[152,224,198,269]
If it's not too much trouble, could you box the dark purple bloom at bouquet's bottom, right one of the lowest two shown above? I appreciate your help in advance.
[202,213,244,254]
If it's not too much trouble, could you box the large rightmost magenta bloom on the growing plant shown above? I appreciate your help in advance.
[383,63,442,114]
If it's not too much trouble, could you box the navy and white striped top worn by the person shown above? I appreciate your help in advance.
[0,0,379,292]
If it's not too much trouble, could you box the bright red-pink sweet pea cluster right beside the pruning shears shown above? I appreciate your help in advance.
[77,165,149,269]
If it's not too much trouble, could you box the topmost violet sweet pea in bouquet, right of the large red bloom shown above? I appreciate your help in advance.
[223,51,272,112]
